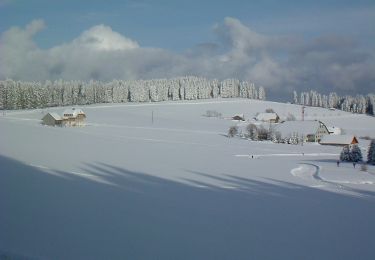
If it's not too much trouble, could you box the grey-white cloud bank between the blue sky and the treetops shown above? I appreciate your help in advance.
[0,17,375,96]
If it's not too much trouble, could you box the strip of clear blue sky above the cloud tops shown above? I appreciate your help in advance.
[0,0,375,50]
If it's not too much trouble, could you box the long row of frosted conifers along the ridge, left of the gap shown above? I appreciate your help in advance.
[0,77,266,110]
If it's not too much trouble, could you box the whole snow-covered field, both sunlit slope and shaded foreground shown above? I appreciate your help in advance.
[0,99,375,259]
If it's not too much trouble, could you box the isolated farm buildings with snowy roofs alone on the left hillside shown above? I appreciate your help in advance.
[42,108,86,126]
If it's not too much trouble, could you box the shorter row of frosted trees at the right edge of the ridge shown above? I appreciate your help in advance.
[293,90,375,115]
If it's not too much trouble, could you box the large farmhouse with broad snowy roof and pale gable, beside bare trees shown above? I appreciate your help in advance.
[275,120,329,142]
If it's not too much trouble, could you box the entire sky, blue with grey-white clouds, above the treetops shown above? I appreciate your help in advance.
[0,0,375,100]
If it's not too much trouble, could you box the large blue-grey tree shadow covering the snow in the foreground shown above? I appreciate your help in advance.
[0,156,375,259]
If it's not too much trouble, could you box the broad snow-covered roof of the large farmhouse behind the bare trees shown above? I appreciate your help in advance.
[275,120,321,137]
